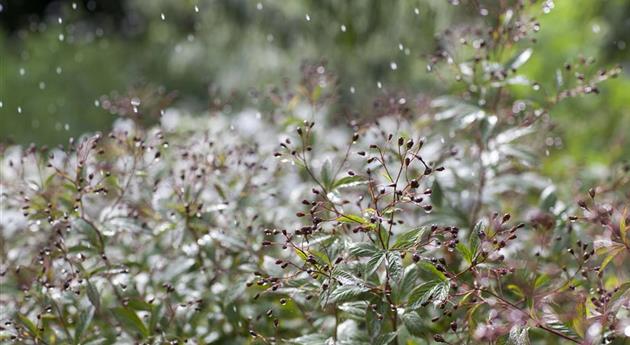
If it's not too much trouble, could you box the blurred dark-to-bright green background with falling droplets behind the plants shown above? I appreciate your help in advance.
[0,0,630,169]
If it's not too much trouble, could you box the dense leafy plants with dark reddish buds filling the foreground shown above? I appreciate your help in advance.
[0,3,630,345]
